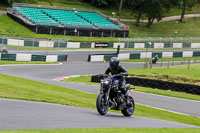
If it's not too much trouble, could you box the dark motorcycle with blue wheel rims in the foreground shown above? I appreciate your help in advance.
[96,74,135,117]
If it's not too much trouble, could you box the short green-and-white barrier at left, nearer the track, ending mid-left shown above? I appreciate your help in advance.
[0,53,67,62]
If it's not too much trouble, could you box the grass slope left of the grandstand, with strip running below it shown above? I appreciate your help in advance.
[0,15,118,42]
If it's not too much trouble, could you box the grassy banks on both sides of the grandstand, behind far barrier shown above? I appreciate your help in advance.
[0,15,200,42]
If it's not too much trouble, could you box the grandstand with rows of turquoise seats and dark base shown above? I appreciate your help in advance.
[7,3,129,37]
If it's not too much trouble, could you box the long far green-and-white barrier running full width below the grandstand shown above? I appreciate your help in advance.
[0,37,200,49]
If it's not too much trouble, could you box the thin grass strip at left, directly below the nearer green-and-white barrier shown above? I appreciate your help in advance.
[0,61,56,65]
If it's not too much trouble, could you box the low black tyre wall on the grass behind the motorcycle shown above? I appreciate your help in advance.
[91,75,200,95]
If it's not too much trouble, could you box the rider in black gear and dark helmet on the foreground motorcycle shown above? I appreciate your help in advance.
[105,57,128,93]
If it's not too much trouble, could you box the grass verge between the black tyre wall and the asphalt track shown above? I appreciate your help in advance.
[64,76,200,101]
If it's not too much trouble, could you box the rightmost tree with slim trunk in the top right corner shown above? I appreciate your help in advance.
[179,0,198,22]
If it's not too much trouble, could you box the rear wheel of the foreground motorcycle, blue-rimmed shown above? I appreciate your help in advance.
[121,97,135,117]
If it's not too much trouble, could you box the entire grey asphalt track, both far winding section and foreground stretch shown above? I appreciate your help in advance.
[0,50,200,130]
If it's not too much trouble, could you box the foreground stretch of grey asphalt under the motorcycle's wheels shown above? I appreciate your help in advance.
[0,99,196,130]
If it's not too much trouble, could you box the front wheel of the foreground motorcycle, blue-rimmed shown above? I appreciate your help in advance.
[96,94,108,115]
